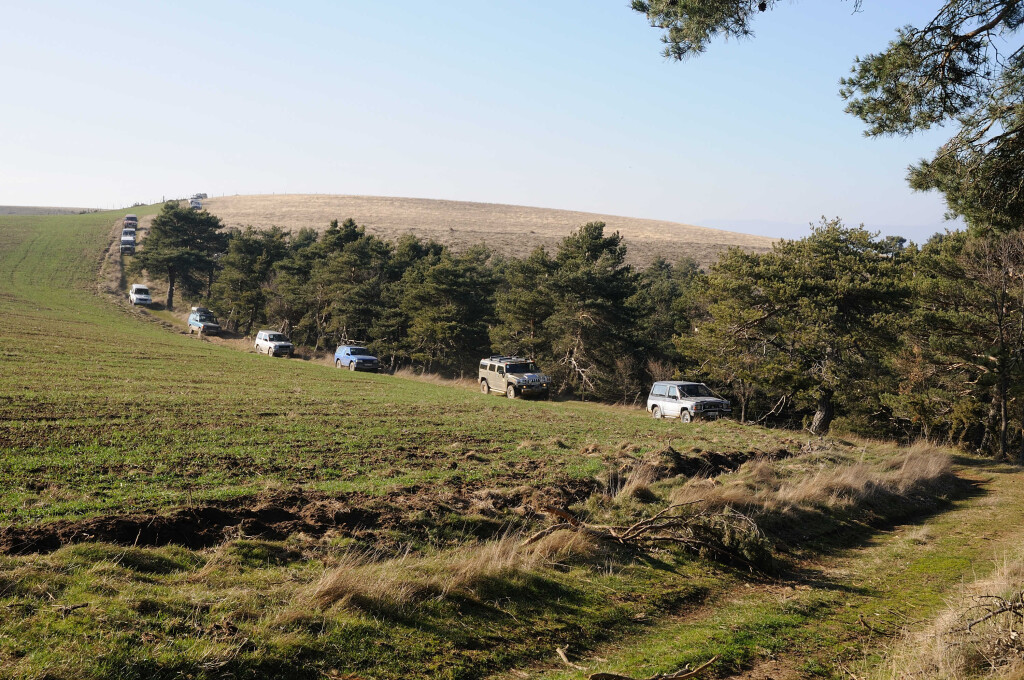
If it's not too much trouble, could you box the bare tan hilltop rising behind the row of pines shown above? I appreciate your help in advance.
[204,194,775,266]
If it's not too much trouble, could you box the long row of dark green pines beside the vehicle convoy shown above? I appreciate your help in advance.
[136,199,1024,460]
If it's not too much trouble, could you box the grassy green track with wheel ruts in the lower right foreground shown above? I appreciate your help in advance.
[524,458,1024,680]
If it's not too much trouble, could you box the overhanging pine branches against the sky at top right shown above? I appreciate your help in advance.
[633,0,1024,230]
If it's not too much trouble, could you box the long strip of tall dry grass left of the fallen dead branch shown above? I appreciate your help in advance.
[305,532,598,610]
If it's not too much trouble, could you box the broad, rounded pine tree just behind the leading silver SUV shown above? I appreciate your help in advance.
[685,219,909,433]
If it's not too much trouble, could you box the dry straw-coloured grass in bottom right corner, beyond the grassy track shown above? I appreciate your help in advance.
[871,553,1024,680]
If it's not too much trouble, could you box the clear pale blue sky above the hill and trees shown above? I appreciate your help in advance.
[0,0,949,241]
